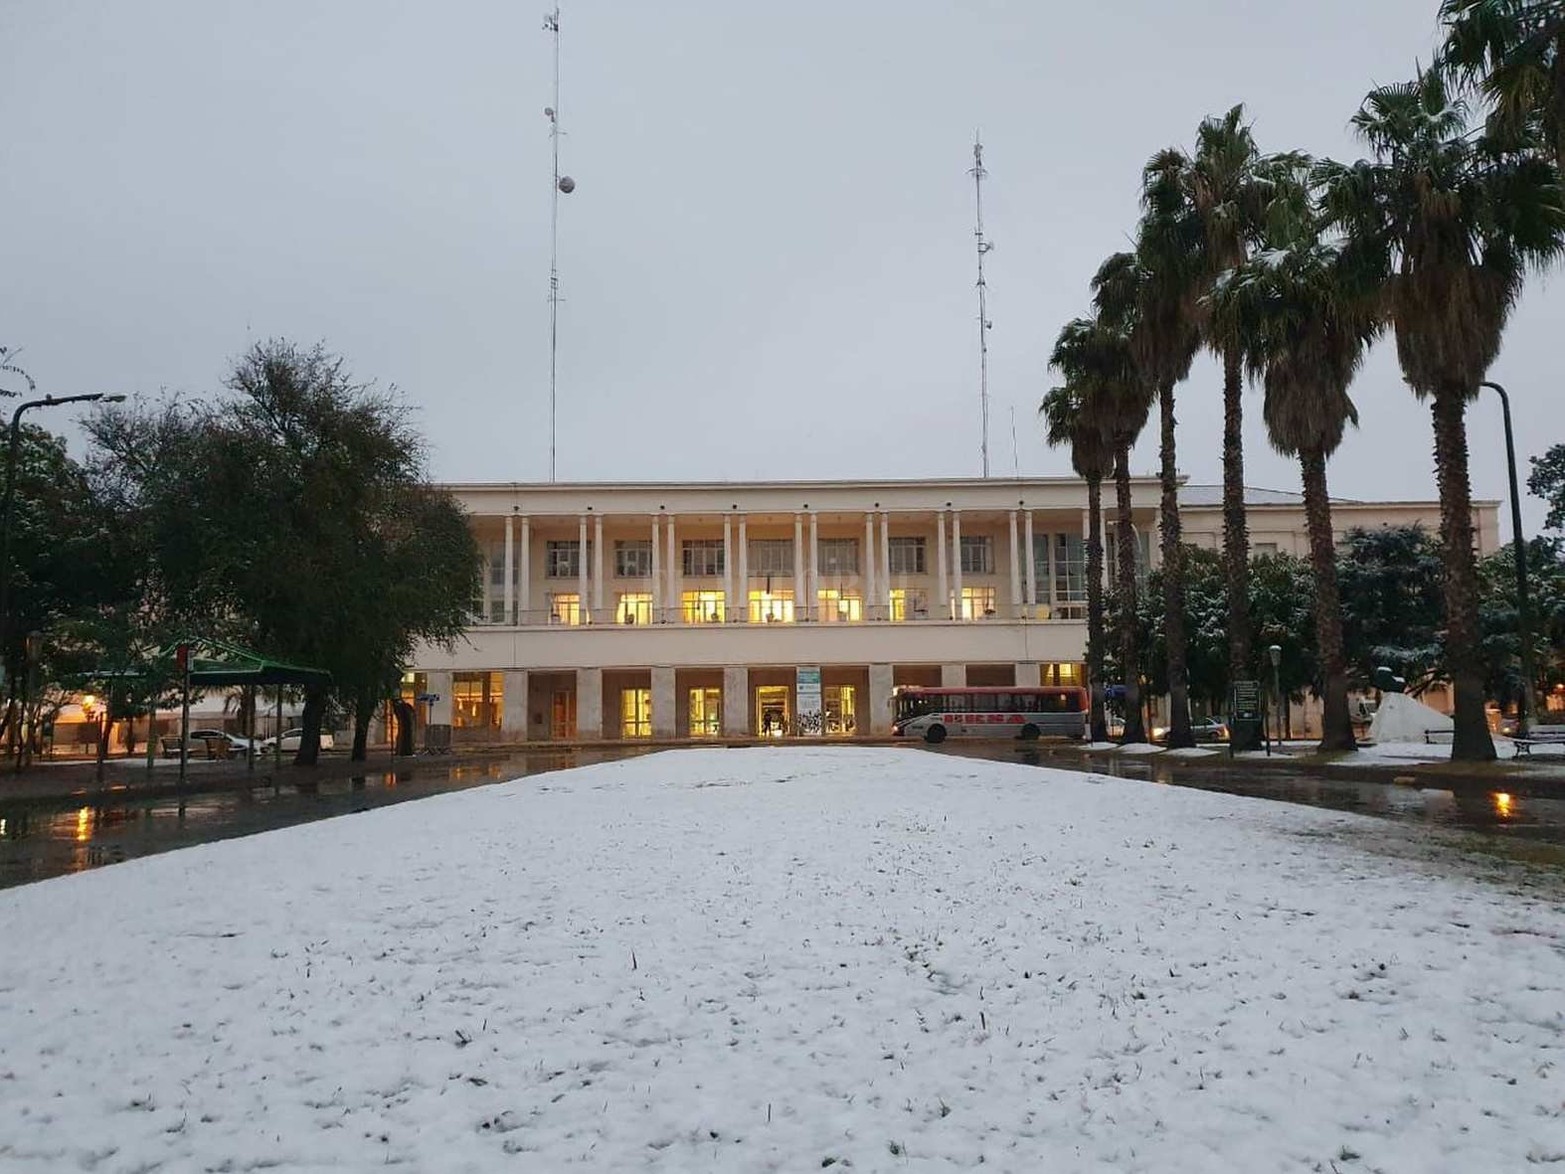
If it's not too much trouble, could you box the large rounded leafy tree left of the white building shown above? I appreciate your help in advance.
[92,340,479,765]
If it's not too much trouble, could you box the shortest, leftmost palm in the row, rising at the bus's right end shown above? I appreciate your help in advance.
[1038,349,1114,742]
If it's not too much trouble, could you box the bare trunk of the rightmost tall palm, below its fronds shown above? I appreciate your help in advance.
[1432,388,1495,762]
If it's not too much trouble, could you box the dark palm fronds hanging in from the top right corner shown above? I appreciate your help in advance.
[1440,0,1565,166]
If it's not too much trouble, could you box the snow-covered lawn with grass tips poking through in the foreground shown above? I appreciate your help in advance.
[0,748,1565,1174]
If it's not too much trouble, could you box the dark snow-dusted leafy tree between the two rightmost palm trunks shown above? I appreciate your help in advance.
[1337,526,1444,695]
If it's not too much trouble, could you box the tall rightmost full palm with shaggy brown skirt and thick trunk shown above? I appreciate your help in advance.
[1318,72,1565,761]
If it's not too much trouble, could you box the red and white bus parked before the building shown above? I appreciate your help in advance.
[892,686,1088,742]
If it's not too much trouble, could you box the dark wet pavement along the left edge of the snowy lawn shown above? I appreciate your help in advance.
[0,748,645,888]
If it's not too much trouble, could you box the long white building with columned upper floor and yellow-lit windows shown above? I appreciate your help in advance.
[404,477,1498,742]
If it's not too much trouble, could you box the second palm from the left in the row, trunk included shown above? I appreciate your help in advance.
[1050,300,1152,742]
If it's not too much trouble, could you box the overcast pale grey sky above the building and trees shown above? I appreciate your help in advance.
[0,0,1562,534]
